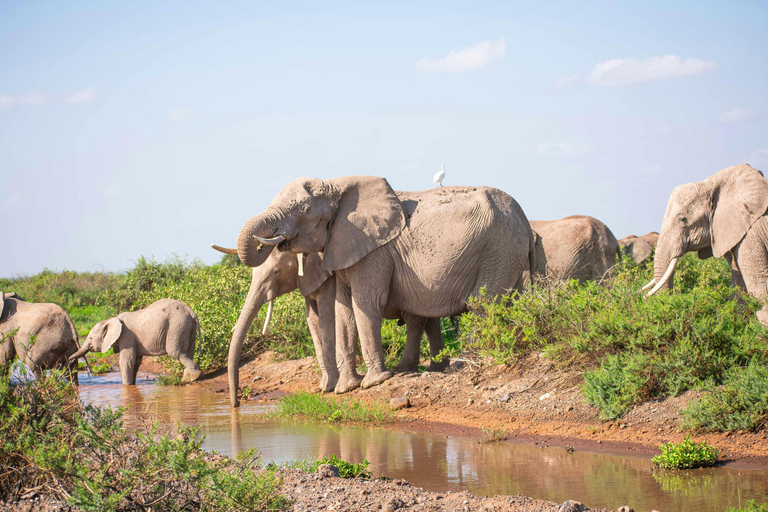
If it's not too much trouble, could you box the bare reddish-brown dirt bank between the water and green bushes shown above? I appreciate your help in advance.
[189,352,768,469]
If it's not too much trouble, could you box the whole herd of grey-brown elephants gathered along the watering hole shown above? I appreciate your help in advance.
[0,164,768,407]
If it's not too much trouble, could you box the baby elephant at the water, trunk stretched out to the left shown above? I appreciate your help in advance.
[69,299,203,386]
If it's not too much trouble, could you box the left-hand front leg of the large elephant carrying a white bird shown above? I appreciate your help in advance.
[334,279,363,393]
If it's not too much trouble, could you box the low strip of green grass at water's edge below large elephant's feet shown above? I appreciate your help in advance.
[277,393,394,425]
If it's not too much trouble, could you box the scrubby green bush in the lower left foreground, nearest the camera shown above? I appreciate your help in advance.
[0,373,289,511]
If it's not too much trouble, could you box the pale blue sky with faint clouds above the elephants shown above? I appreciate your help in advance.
[0,1,768,277]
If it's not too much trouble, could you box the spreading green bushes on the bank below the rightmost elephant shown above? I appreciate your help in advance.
[462,255,768,424]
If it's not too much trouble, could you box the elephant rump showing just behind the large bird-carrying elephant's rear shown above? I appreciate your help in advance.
[531,215,619,284]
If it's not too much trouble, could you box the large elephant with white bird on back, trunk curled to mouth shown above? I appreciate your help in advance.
[237,176,534,400]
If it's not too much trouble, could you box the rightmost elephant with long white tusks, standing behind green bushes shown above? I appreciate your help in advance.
[643,164,768,326]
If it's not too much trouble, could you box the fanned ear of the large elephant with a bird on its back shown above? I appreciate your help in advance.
[323,176,406,270]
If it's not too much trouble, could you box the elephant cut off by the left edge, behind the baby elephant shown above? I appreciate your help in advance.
[0,292,78,384]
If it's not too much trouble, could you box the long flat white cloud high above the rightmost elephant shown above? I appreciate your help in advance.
[589,55,717,86]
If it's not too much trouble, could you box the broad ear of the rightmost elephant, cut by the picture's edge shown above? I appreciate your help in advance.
[705,164,768,258]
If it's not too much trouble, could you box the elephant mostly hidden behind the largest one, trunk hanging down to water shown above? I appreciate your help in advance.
[211,240,448,407]
